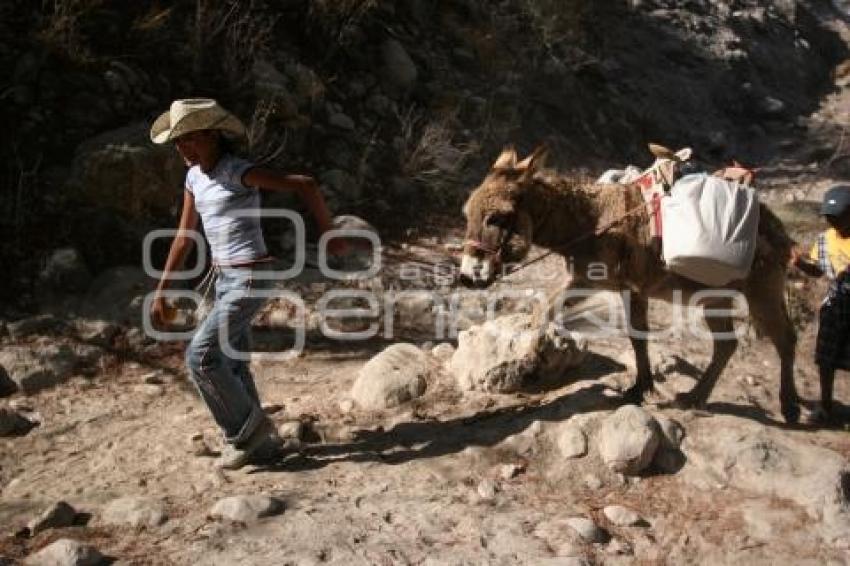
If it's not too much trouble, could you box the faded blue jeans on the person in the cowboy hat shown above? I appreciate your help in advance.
[186,264,268,446]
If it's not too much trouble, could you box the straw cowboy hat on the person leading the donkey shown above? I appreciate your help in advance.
[151,98,245,143]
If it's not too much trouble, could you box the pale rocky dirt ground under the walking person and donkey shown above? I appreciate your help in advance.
[0,149,850,564]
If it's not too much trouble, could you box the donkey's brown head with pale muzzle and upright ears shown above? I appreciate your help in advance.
[460,147,546,287]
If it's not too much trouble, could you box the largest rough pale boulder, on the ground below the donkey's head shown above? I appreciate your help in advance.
[449,314,587,393]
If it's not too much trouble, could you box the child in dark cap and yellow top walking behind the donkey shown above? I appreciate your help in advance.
[792,185,850,421]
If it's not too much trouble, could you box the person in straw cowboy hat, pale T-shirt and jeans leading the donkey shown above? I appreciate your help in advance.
[150,98,344,469]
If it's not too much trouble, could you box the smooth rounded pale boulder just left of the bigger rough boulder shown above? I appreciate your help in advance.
[351,343,431,409]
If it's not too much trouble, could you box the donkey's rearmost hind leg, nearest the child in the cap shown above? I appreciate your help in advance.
[747,286,800,424]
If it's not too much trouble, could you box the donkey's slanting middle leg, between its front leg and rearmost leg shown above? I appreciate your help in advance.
[676,299,738,409]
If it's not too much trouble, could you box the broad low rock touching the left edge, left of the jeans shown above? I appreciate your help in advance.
[0,344,77,394]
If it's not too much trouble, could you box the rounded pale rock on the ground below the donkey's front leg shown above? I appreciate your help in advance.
[598,405,661,475]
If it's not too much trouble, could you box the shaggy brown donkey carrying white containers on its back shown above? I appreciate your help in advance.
[460,146,800,423]
